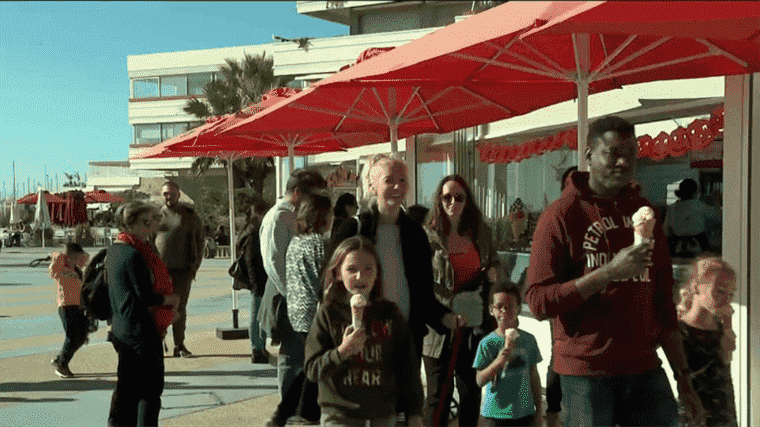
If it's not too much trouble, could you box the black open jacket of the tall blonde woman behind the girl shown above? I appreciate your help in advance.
[325,205,451,354]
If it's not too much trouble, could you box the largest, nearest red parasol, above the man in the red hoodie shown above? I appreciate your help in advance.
[296,1,760,166]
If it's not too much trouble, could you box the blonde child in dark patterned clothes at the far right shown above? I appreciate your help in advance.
[677,257,737,426]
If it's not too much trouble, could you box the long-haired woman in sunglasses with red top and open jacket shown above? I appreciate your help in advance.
[422,175,499,426]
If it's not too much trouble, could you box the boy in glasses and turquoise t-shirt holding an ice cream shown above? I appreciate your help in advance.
[473,283,543,427]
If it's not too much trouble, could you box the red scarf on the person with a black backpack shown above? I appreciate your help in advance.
[116,232,174,336]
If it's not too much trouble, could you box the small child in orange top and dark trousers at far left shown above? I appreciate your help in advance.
[48,243,89,378]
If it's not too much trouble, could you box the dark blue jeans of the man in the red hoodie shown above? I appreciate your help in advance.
[560,368,678,427]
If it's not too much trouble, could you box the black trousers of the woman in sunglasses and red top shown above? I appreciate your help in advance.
[422,328,480,427]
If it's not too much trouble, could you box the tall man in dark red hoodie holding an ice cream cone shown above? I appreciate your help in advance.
[526,117,704,426]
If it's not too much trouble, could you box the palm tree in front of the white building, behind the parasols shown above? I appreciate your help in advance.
[183,52,290,202]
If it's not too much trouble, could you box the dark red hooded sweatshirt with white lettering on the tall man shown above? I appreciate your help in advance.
[526,172,678,376]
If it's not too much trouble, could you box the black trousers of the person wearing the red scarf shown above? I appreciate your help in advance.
[108,335,164,426]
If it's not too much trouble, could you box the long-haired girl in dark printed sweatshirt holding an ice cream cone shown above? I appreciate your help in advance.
[304,236,423,427]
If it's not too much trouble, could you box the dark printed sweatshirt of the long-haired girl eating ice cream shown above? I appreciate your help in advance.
[304,300,423,419]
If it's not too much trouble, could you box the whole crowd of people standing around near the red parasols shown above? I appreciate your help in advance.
[50,117,736,427]
